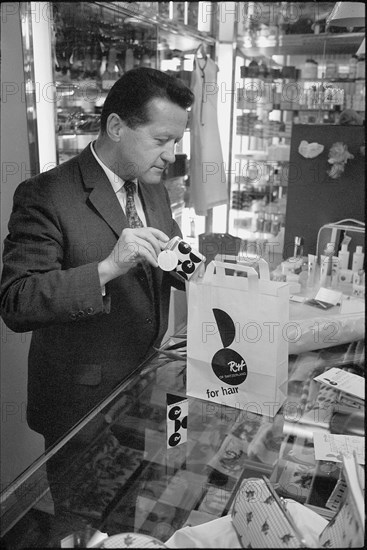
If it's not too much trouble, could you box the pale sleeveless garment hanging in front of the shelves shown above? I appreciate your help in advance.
[190,56,228,216]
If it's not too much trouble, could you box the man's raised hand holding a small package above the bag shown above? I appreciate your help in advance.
[98,227,169,286]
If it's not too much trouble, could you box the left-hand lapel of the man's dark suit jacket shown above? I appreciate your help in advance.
[79,145,128,237]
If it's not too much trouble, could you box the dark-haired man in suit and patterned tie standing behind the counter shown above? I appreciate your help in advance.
[1,68,193,446]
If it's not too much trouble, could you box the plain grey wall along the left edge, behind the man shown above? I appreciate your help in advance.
[0,2,43,488]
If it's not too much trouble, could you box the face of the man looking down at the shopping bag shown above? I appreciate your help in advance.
[116,98,188,183]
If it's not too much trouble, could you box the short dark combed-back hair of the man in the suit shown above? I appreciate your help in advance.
[101,67,194,133]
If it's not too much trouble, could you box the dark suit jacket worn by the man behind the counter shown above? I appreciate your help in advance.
[1,146,180,435]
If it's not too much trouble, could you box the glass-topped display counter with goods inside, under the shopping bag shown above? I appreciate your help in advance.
[1,334,364,550]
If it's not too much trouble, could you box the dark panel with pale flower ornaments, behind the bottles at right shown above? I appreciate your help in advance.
[284,124,366,257]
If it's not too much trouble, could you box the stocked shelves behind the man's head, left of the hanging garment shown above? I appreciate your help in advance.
[52,2,216,232]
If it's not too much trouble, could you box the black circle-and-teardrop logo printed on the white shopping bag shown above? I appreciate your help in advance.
[212,308,247,386]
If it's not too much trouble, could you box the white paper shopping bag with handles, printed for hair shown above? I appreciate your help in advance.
[187,261,289,417]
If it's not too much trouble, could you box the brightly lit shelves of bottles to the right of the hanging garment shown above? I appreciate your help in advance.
[228,3,365,248]
